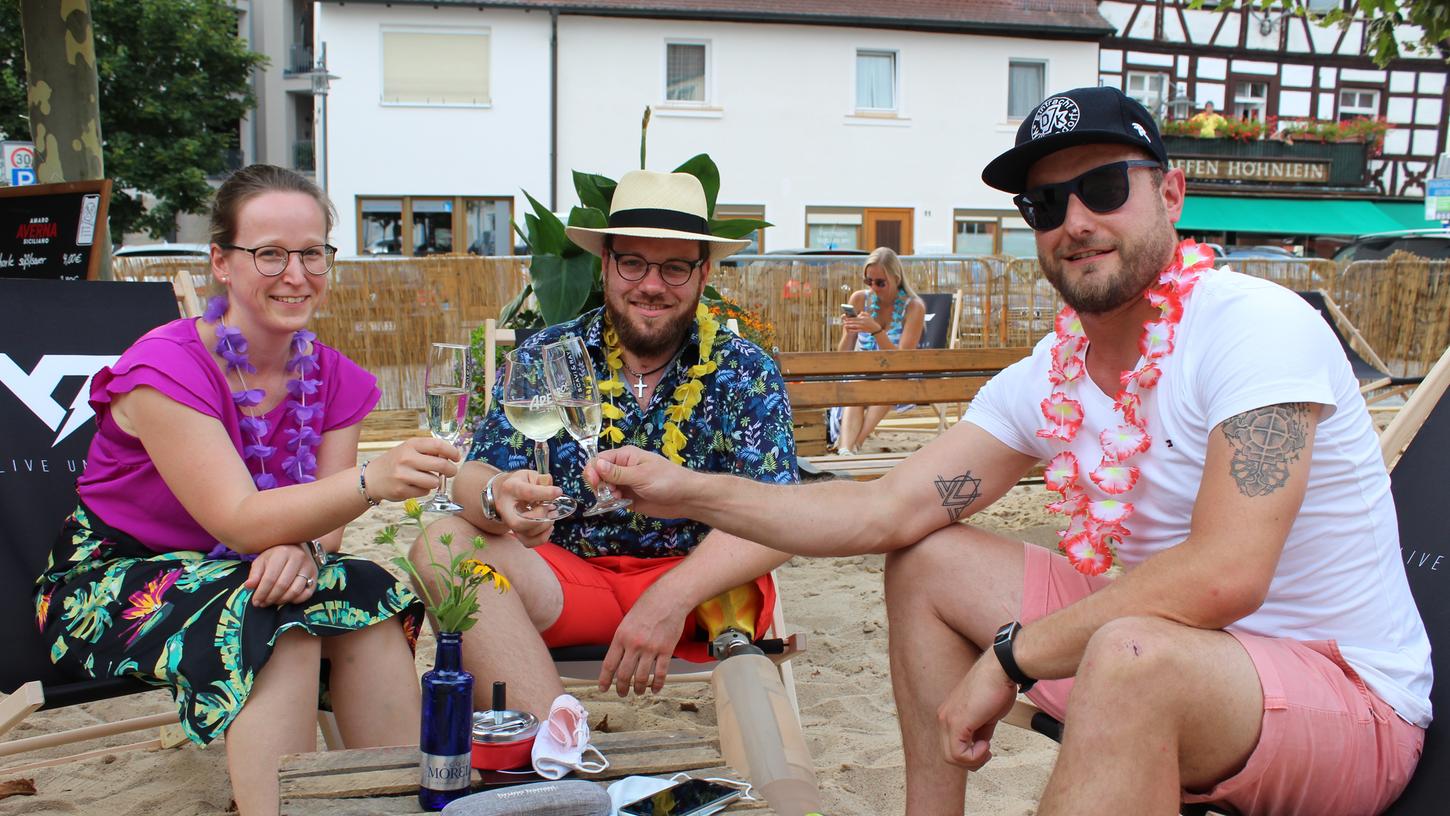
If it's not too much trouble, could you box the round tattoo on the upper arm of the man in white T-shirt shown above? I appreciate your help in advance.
[1219,403,1312,496]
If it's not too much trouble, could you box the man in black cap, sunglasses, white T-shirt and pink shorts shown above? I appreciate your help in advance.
[589,88,1431,816]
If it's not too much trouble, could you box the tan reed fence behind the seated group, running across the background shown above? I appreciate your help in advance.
[115,255,1450,409]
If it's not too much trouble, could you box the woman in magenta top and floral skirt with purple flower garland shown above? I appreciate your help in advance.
[36,165,458,816]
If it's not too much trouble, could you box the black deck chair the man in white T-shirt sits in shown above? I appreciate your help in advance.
[1003,342,1450,816]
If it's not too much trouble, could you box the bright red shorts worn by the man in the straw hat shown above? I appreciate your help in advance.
[534,544,776,662]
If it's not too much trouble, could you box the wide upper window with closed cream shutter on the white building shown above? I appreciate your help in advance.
[381,29,490,107]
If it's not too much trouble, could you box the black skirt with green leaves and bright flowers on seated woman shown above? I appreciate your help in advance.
[35,504,423,745]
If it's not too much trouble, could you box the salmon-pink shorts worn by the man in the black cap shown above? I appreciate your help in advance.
[1021,544,1425,816]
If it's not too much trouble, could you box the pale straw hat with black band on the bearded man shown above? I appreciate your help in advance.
[564,170,750,261]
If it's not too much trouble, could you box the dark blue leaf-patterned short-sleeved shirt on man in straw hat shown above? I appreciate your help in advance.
[468,309,796,558]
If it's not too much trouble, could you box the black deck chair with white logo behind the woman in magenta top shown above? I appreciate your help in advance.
[0,280,187,757]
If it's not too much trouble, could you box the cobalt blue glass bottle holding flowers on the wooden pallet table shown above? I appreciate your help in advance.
[418,632,473,810]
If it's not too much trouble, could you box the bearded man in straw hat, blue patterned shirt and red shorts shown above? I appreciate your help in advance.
[412,171,796,727]
